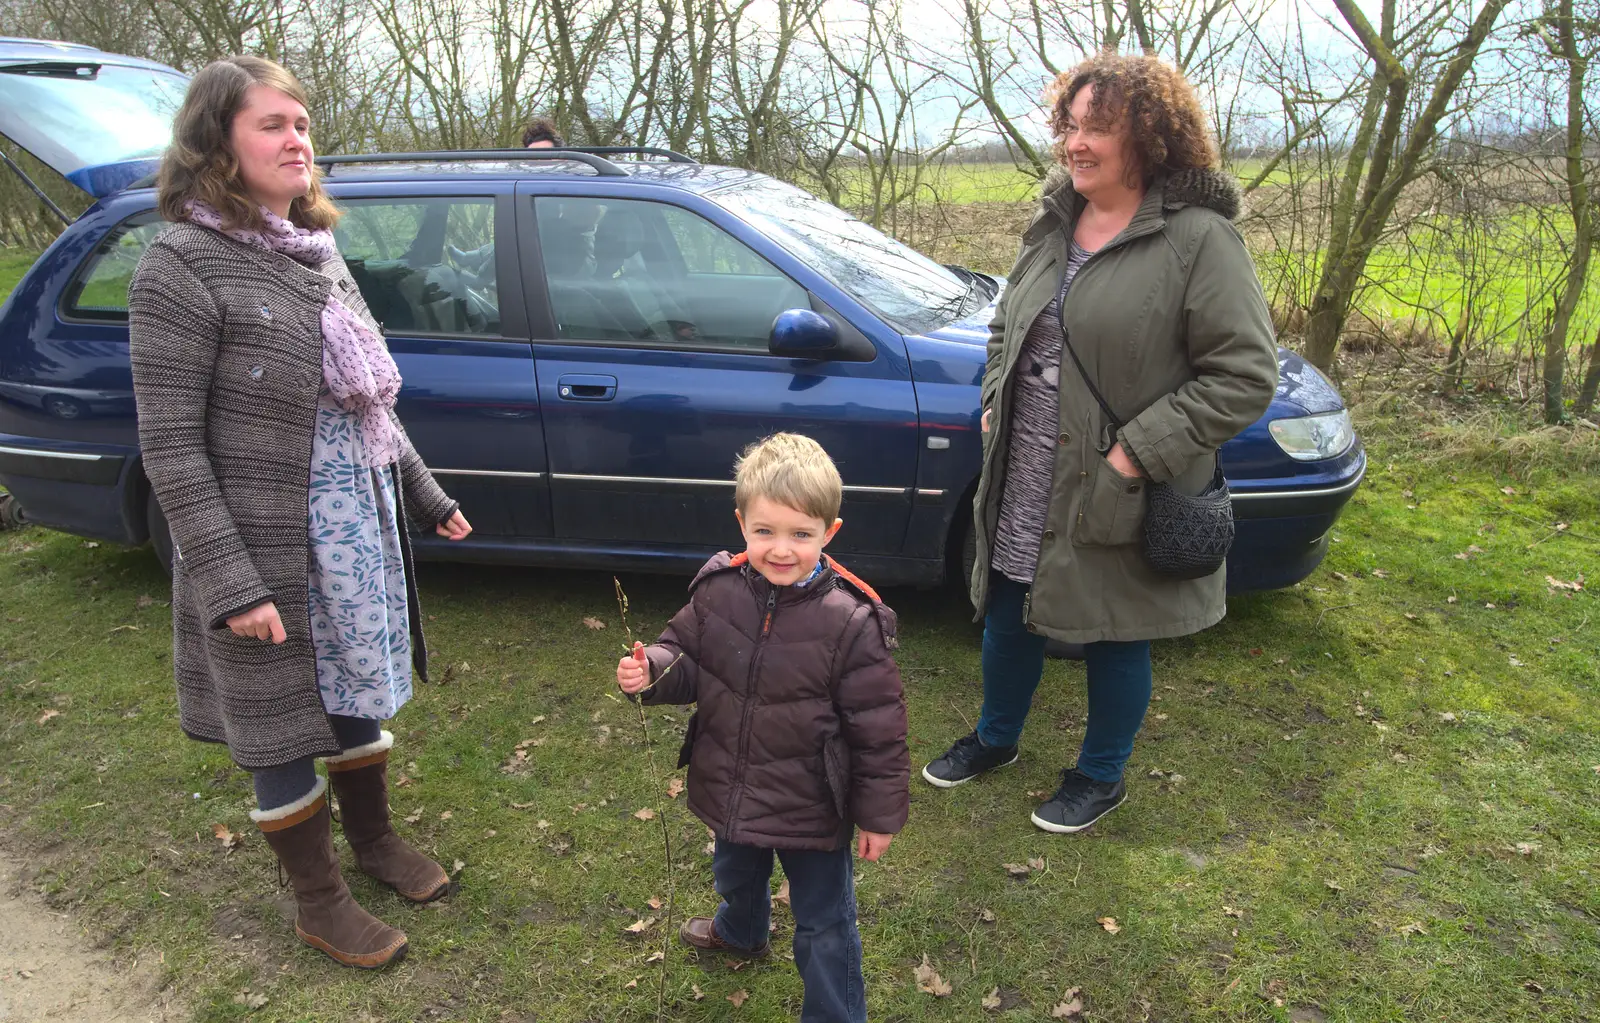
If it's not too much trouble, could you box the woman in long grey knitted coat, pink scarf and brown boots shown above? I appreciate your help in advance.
[128,56,472,969]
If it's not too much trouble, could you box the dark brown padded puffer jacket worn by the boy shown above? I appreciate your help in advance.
[643,552,910,850]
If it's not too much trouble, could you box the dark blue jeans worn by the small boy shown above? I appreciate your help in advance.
[710,839,867,1023]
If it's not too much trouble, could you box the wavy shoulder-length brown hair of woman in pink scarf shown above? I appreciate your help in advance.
[158,56,339,231]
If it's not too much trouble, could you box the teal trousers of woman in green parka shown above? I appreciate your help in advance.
[978,572,1150,781]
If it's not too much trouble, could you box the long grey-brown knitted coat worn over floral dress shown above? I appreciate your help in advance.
[128,224,456,768]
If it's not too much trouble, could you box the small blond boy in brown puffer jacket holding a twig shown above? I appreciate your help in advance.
[616,434,910,1023]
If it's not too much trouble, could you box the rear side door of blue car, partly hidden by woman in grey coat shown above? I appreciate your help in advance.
[334,183,550,543]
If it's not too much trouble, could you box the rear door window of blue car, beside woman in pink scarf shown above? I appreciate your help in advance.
[333,197,501,336]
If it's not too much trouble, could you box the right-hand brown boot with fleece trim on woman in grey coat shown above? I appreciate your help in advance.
[326,732,450,903]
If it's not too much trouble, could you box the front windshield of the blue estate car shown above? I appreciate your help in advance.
[712,178,981,335]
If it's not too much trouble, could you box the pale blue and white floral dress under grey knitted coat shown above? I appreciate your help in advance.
[309,387,411,719]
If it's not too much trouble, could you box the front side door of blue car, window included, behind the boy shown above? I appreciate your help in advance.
[517,184,918,556]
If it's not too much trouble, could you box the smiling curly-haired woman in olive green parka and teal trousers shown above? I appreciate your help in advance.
[923,53,1278,832]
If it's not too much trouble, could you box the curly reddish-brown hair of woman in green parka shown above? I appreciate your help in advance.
[1045,53,1219,184]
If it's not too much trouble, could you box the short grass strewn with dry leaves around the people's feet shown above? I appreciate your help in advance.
[0,416,1600,1023]
